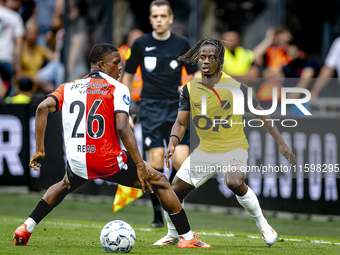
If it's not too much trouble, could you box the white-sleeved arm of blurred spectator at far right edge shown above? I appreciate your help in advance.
[311,37,340,99]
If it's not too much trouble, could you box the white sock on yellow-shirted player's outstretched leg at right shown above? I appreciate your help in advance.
[236,187,268,227]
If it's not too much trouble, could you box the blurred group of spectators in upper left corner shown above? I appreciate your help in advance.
[0,0,65,103]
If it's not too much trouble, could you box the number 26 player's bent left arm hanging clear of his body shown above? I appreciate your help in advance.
[30,97,56,170]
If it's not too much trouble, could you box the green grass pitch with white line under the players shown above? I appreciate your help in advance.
[0,193,340,255]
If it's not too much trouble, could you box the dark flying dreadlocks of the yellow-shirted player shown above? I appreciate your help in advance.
[177,37,224,69]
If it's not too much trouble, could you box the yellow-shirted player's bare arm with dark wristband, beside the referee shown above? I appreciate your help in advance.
[165,111,190,170]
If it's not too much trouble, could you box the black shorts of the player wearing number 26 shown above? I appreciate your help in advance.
[66,151,139,190]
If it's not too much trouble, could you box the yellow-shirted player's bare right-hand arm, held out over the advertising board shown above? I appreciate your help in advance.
[254,105,296,164]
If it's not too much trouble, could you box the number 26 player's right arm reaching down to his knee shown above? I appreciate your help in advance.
[115,113,153,193]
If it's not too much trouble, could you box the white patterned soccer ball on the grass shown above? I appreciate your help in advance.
[100,220,136,253]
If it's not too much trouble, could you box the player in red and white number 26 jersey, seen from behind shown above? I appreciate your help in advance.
[13,43,211,248]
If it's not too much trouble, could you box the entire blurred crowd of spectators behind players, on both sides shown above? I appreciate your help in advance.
[0,0,340,111]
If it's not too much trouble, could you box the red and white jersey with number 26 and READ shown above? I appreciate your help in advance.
[48,71,130,180]
